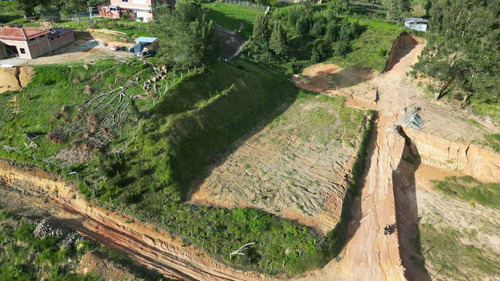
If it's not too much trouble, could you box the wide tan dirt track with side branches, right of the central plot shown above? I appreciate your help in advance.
[296,35,500,281]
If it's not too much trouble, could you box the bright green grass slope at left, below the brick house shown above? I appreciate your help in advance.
[0,60,153,164]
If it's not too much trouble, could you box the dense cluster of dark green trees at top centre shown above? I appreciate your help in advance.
[250,0,362,62]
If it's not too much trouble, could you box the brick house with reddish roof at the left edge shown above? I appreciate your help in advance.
[0,26,75,59]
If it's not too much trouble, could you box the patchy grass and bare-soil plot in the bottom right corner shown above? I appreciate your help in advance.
[415,167,500,280]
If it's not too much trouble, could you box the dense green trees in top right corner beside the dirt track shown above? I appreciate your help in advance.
[415,0,500,103]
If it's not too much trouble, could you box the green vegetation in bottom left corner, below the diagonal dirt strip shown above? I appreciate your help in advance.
[0,203,163,281]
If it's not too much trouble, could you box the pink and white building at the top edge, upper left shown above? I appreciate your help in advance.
[98,0,175,22]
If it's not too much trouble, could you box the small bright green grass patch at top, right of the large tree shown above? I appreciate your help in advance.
[202,2,264,38]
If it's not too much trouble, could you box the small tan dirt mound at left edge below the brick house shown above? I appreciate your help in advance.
[0,66,35,94]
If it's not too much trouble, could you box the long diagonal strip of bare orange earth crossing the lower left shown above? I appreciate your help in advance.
[0,161,269,280]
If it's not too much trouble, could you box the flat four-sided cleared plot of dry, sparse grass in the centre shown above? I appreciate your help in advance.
[190,94,364,234]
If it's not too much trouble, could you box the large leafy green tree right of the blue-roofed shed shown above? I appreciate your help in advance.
[152,0,216,69]
